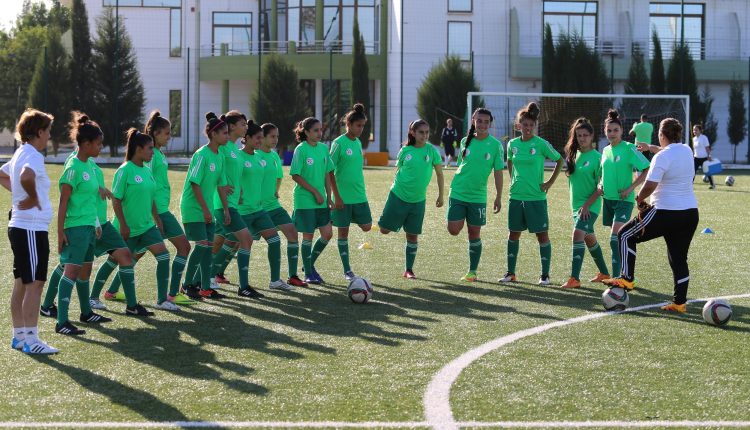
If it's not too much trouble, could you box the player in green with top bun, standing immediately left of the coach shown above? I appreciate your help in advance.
[604,109,649,282]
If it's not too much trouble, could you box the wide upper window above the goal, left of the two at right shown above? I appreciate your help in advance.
[544,0,598,47]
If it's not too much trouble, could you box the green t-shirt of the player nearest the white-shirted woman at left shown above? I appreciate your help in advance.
[58,157,99,228]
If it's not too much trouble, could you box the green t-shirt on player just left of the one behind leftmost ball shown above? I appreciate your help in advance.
[289,142,334,209]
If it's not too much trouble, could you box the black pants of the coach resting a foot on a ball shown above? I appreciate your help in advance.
[617,208,698,305]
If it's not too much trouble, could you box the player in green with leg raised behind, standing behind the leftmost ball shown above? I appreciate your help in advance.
[329,103,372,281]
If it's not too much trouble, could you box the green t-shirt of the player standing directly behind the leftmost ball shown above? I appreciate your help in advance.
[331,134,367,204]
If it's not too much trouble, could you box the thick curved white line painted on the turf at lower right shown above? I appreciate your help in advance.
[422,294,750,430]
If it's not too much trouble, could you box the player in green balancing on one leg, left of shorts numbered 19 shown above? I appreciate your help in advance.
[378,119,444,279]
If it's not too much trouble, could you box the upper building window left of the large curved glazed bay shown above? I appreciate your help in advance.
[213,12,253,55]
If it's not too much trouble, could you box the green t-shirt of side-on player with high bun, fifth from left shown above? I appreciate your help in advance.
[180,145,226,223]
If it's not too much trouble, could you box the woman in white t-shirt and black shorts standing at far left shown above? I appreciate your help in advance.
[0,109,60,354]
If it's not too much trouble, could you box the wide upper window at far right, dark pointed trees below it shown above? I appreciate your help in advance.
[649,3,706,60]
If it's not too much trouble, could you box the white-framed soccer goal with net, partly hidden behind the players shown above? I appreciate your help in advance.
[466,92,690,150]
